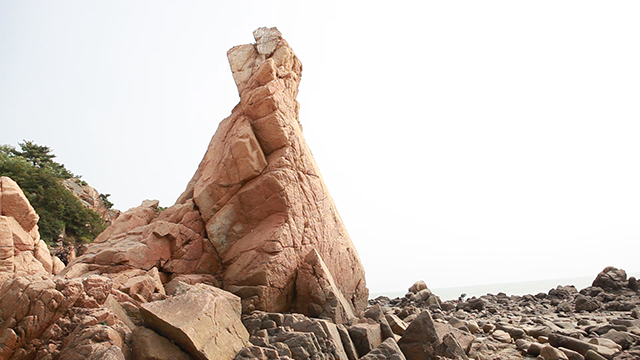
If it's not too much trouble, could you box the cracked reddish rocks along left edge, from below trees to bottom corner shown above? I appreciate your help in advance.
[0,177,136,359]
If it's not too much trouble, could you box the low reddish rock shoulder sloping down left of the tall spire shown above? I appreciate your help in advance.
[61,201,220,301]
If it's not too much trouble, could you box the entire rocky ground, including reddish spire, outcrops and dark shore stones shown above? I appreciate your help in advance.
[0,28,640,360]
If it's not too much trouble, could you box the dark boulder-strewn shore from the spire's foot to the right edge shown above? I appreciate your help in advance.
[230,267,640,360]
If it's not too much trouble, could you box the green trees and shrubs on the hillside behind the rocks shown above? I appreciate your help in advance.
[0,140,106,245]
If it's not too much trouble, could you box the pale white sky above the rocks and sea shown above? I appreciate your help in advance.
[0,0,640,292]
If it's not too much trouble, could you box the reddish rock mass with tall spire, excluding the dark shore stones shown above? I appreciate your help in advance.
[0,29,370,360]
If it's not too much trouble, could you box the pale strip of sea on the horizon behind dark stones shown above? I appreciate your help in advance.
[369,276,595,301]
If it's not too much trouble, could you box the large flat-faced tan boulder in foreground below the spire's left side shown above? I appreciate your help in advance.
[140,284,249,360]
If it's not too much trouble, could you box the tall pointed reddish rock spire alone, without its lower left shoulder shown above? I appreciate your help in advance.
[178,28,368,315]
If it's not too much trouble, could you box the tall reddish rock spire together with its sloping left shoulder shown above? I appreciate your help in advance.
[65,28,368,322]
